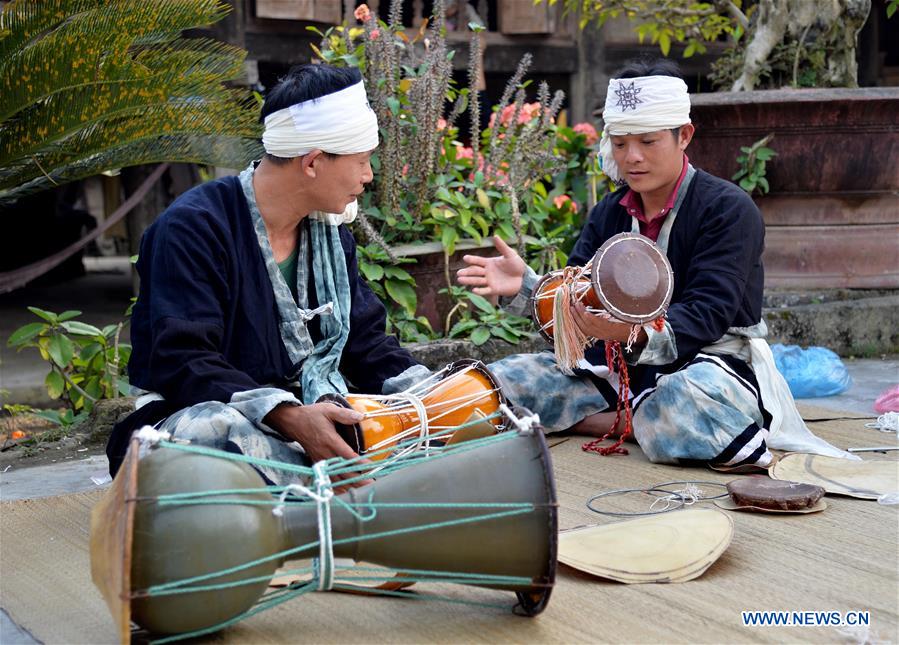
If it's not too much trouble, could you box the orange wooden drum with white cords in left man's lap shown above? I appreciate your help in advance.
[319,360,506,460]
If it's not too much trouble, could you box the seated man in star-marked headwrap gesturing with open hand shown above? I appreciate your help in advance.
[458,60,849,469]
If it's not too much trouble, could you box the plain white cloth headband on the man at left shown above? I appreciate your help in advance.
[262,81,378,159]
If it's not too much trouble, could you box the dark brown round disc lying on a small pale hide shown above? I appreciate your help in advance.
[715,477,827,513]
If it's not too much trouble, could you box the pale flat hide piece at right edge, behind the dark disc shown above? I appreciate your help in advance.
[770,453,899,499]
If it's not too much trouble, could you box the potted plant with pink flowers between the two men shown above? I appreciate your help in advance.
[306,0,602,344]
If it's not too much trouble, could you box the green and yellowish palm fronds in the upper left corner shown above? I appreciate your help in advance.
[0,0,260,201]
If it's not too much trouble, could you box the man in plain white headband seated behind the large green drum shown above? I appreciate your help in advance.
[107,65,429,484]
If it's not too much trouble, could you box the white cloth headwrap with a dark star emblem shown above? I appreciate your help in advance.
[599,76,690,183]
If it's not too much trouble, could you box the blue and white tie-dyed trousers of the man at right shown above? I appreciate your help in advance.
[489,352,772,468]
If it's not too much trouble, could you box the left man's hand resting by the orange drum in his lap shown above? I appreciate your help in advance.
[264,403,371,486]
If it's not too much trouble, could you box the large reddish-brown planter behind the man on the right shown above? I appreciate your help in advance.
[688,87,899,289]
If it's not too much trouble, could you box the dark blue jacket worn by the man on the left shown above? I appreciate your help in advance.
[107,177,416,468]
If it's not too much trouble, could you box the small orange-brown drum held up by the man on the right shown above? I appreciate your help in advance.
[531,233,674,342]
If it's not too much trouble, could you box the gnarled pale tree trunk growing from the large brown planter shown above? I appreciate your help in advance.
[731,0,871,92]
